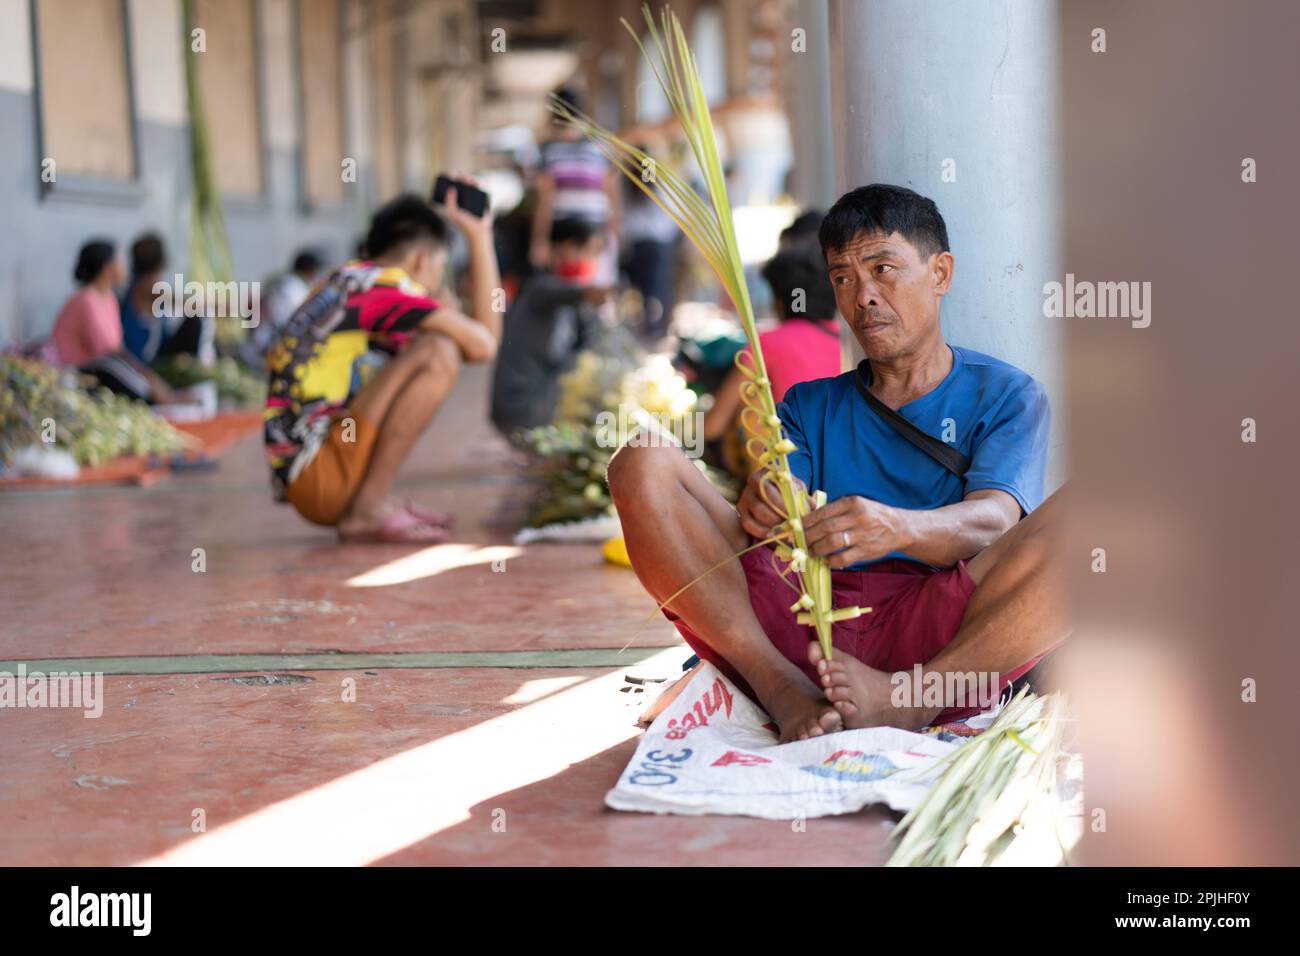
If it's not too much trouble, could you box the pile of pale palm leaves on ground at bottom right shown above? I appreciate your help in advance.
[888,689,1078,866]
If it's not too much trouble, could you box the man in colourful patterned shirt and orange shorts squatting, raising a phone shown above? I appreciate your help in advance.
[265,193,502,542]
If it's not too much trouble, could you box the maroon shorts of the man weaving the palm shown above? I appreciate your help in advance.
[664,548,1035,723]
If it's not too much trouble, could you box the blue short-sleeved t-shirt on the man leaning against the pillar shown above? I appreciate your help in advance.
[777,346,1052,567]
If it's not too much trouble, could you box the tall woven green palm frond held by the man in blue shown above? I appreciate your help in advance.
[551,7,871,658]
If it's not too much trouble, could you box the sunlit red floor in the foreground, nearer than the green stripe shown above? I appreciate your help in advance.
[0,669,889,865]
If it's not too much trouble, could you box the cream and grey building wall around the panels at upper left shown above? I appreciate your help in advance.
[0,0,475,345]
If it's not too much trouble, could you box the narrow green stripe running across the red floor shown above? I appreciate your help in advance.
[0,648,670,674]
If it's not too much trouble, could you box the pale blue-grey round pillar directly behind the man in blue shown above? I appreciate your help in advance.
[829,0,1065,488]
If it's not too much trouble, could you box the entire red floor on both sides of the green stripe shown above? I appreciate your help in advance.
[0,369,888,865]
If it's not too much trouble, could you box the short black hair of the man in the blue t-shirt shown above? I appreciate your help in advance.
[818,182,949,259]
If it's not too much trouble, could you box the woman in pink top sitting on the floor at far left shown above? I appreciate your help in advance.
[51,239,173,403]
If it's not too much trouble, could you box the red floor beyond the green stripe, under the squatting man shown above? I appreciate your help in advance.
[0,377,677,658]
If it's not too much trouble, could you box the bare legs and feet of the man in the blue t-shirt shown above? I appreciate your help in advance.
[608,446,1069,740]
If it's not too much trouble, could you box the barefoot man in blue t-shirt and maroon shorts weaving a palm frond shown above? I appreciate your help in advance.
[608,185,1066,740]
